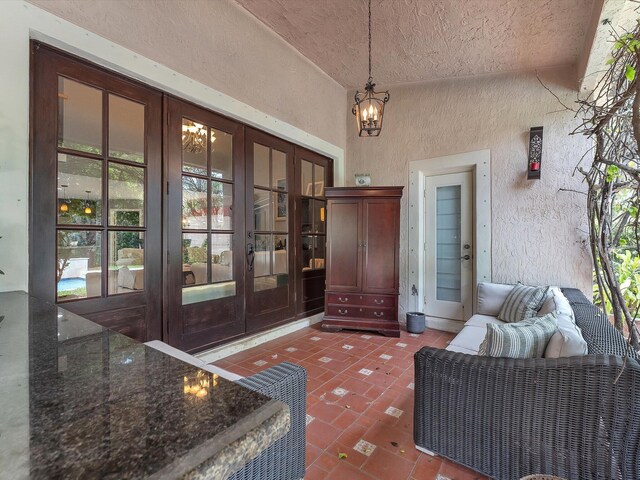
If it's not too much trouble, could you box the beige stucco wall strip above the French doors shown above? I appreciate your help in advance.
[29,0,345,147]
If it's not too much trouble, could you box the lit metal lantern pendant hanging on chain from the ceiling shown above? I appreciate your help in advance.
[351,0,389,137]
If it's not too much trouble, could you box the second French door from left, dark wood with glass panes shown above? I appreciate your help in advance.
[165,98,246,351]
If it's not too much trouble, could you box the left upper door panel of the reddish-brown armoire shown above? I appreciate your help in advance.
[327,200,362,292]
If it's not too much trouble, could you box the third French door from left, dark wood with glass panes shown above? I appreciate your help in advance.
[245,127,296,332]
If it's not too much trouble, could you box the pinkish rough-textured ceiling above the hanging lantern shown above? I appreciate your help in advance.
[236,0,593,88]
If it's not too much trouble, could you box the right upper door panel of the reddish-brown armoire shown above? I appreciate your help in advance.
[362,199,400,293]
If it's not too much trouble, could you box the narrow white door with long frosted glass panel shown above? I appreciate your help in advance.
[424,172,474,321]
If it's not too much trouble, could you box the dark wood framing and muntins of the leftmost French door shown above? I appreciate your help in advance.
[29,41,162,339]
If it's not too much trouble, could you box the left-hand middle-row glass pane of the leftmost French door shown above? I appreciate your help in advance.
[58,153,102,225]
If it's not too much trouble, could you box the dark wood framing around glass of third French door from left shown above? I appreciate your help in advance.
[243,127,298,333]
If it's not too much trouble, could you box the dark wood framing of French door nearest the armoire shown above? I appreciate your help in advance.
[294,145,333,318]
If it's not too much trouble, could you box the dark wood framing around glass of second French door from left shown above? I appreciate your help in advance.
[163,96,246,351]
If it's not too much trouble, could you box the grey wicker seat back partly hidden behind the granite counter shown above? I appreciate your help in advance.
[230,362,307,480]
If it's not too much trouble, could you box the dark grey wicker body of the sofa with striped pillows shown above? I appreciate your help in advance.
[414,289,640,480]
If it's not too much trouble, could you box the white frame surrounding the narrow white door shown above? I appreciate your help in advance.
[406,149,492,332]
